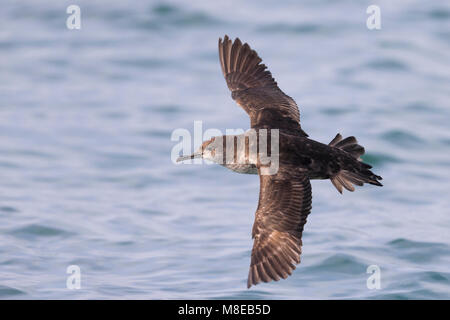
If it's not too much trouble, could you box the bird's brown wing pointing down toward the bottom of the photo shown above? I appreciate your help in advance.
[247,164,311,288]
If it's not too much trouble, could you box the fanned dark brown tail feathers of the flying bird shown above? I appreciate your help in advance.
[328,133,383,193]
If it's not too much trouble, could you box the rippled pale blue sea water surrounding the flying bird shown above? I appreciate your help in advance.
[0,0,450,299]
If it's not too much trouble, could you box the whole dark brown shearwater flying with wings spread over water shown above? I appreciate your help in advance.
[177,36,382,288]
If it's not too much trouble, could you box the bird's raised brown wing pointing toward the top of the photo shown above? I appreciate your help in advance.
[219,36,307,136]
